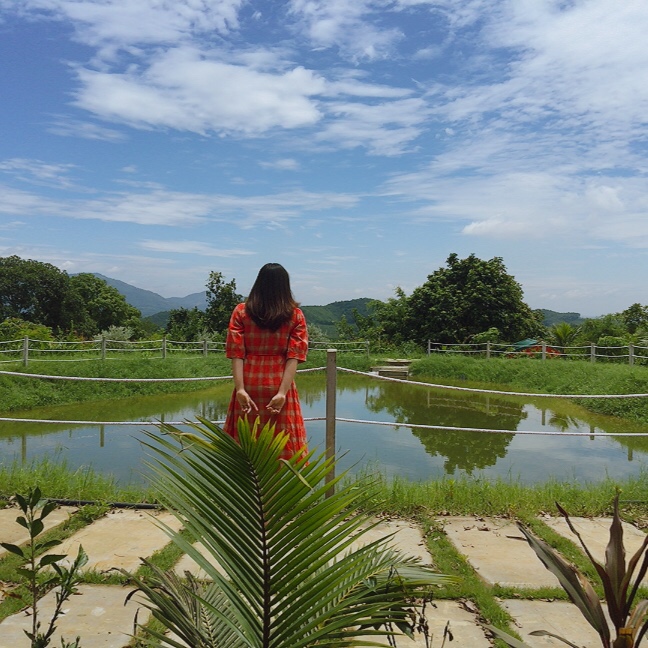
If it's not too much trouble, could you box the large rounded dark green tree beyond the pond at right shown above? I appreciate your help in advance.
[404,254,543,344]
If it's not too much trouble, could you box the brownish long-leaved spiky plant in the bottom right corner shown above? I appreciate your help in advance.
[488,494,648,648]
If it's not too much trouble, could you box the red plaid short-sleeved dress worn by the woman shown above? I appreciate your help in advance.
[224,304,308,459]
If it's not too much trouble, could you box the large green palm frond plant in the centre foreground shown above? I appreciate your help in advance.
[126,419,450,648]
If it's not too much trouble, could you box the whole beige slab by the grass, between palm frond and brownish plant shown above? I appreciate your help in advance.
[438,517,560,588]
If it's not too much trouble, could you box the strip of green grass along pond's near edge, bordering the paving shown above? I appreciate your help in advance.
[0,459,648,526]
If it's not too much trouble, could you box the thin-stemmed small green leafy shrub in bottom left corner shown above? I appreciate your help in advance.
[0,487,88,648]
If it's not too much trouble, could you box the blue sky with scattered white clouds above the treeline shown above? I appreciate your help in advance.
[0,0,648,316]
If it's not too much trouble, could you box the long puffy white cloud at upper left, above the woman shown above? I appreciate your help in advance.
[76,47,324,135]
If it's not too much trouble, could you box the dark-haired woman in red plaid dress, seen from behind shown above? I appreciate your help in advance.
[224,263,308,459]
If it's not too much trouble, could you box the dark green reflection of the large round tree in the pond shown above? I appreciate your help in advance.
[367,383,526,474]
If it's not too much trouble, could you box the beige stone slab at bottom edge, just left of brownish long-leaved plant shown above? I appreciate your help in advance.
[502,599,601,648]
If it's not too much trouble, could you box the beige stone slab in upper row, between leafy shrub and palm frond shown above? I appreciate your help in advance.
[41,509,181,572]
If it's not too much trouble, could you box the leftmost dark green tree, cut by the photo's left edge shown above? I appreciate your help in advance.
[0,256,80,331]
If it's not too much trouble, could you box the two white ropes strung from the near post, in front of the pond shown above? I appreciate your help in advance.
[0,366,648,438]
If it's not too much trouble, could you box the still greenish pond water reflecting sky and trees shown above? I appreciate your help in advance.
[0,374,648,484]
